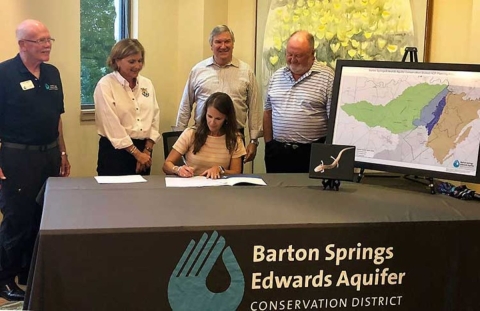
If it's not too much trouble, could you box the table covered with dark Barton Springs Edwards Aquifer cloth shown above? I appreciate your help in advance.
[24,174,480,310]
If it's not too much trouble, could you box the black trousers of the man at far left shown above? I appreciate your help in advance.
[0,144,61,282]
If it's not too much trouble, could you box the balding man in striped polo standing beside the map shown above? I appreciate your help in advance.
[263,31,334,173]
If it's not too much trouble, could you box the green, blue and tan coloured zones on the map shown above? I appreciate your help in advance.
[342,83,480,164]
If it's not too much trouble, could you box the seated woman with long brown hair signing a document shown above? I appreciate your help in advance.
[163,92,247,179]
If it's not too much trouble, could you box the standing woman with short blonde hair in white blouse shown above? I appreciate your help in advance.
[93,39,160,176]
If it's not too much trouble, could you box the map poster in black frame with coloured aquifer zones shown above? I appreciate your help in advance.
[332,65,480,178]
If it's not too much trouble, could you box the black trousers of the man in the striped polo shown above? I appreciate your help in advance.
[265,137,325,173]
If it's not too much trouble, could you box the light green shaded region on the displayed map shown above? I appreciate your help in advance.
[342,83,447,134]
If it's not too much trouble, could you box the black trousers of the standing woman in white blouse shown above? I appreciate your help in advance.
[97,136,150,176]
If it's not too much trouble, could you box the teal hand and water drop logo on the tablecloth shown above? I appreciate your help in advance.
[168,231,245,311]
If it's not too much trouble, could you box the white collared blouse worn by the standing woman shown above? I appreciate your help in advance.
[93,71,160,149]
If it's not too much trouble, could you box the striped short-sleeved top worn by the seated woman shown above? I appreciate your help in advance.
[173,128,247,175]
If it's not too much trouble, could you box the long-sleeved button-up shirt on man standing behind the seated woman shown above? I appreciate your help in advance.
[176,57,263,139]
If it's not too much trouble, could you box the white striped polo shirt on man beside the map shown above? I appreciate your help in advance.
[264,61,334,144]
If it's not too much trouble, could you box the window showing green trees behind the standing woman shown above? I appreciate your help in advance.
[80,0,130,110]
